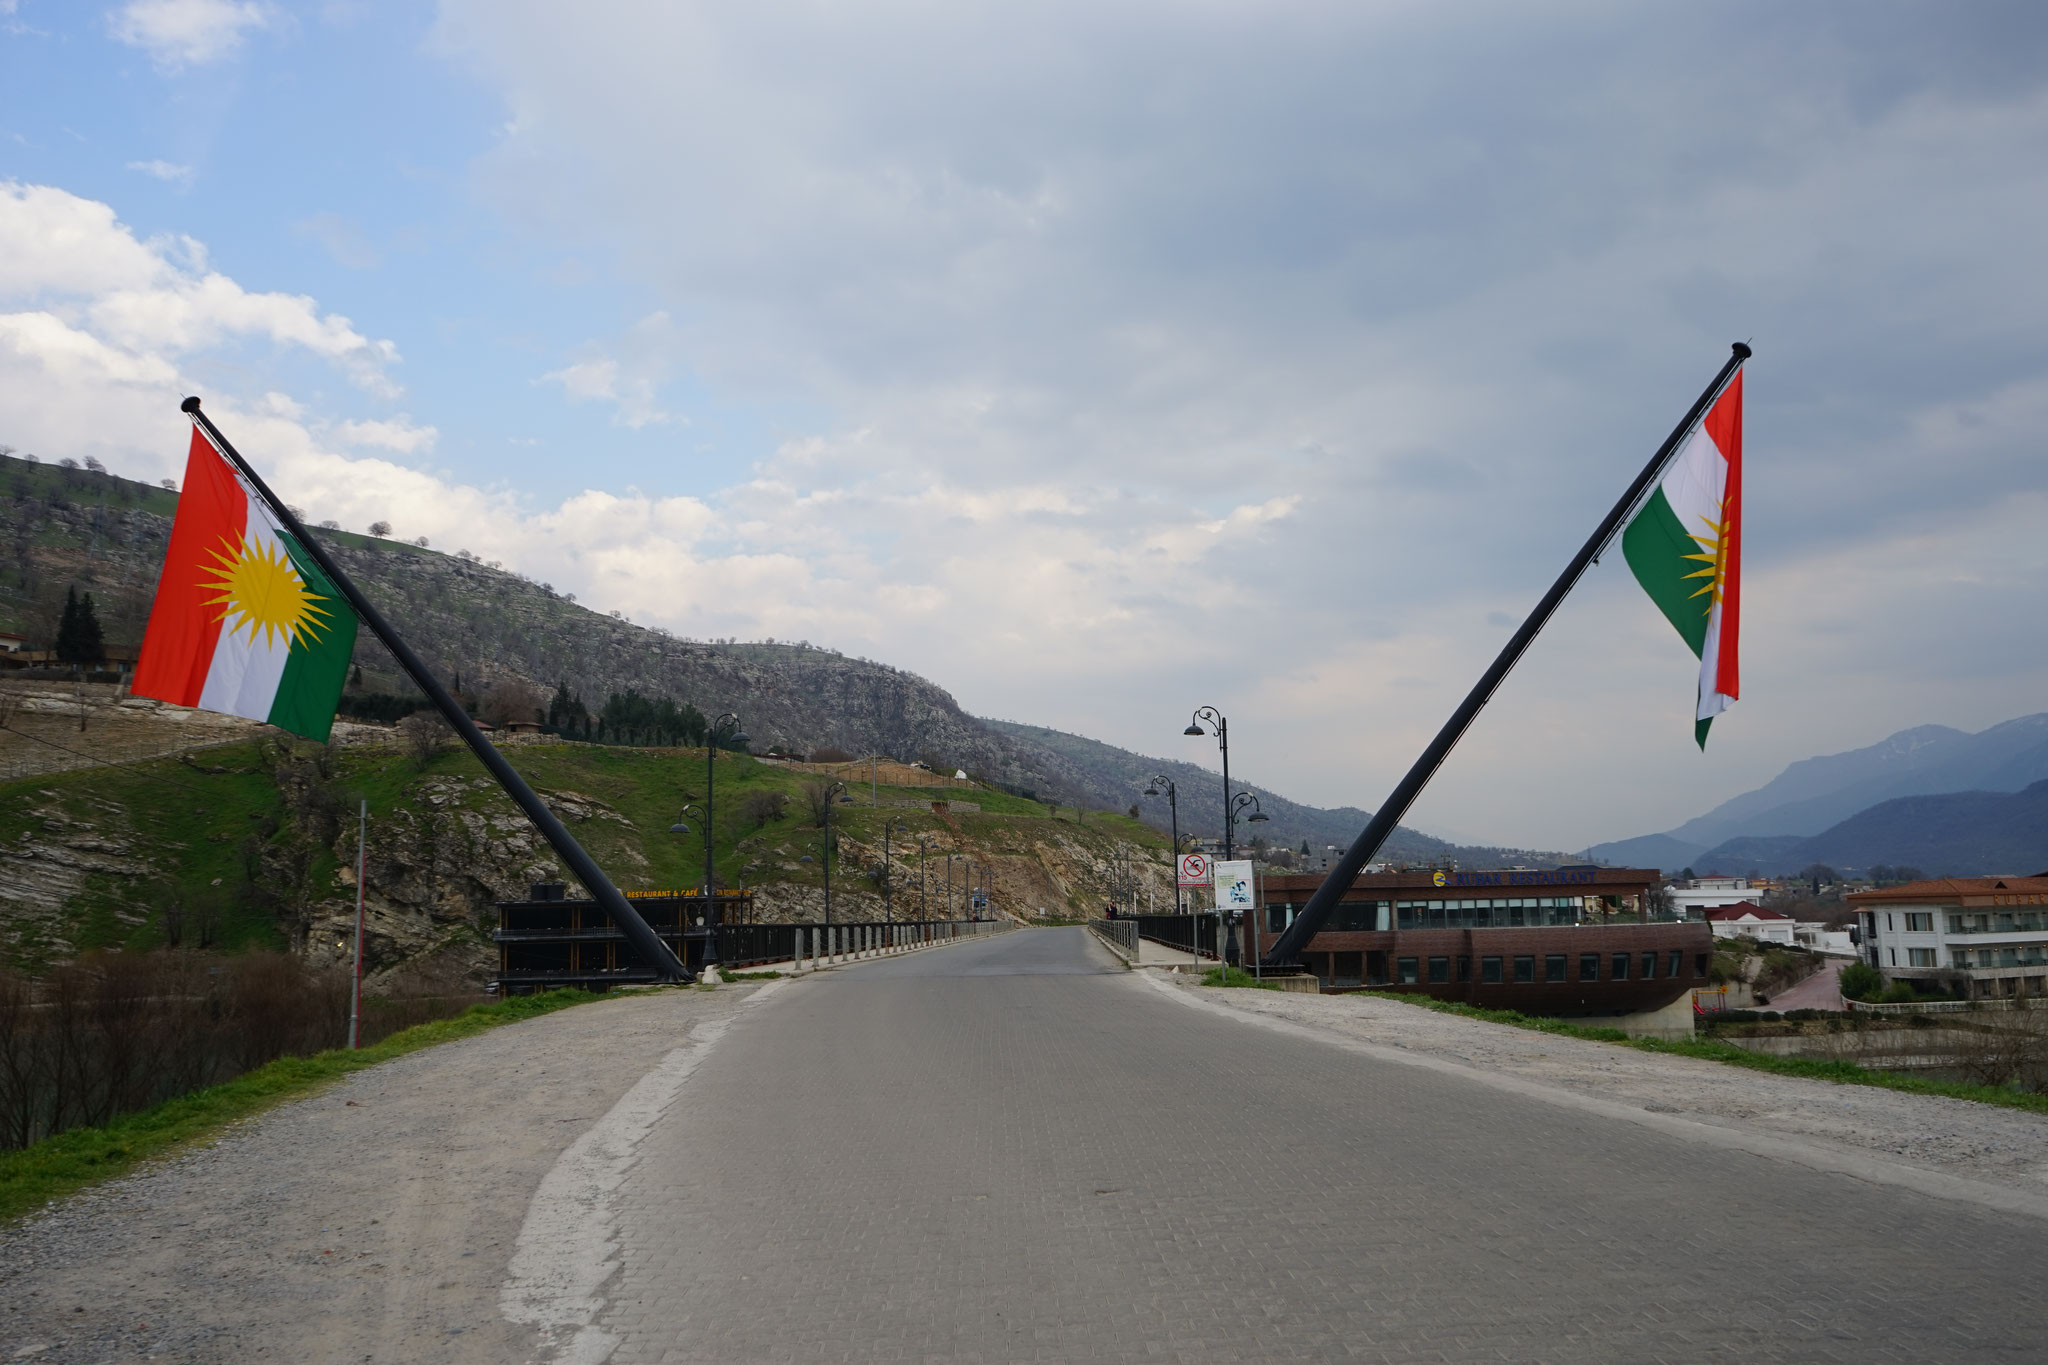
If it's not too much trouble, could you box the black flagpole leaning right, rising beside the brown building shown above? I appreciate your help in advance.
[1266,342,1749,968]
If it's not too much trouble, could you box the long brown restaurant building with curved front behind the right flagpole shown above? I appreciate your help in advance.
[1249,868,1714,1015]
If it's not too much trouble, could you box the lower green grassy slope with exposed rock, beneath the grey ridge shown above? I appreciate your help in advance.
[0,729,1171,980]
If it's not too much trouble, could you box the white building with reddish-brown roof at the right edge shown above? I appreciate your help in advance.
[1849,876,2048,999]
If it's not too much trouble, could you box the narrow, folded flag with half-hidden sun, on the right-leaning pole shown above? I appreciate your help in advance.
[1622,370,1743,749]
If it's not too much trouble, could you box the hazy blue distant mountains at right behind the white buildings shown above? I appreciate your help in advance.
[1591,712,2048,876]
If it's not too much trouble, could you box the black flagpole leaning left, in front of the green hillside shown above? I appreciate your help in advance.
[180,397,690,980]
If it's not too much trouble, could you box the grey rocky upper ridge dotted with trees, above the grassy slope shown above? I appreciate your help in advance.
[0,444,1559,866]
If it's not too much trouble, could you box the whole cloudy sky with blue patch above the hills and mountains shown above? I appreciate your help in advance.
[0,0,2048,847]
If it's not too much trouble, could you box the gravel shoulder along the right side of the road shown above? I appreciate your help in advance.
[1147,972,2048,1199]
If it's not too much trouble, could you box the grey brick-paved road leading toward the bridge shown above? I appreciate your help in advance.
[598,929,2048,1363]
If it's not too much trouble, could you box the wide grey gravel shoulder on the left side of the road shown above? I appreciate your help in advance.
[0,986,754,1363]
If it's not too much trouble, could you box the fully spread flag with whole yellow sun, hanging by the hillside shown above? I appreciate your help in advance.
[131,424,356,741]
